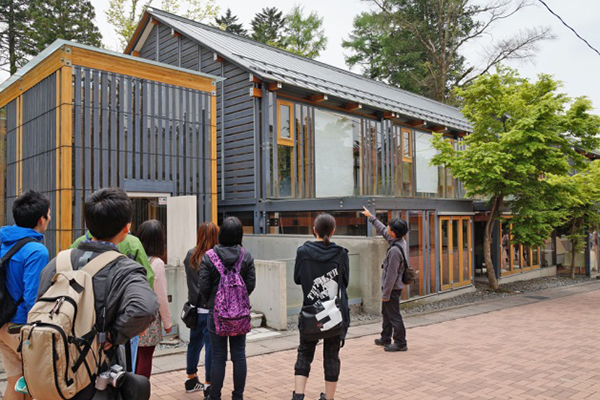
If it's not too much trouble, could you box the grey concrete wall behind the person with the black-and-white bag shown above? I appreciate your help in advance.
[243,235,388,314]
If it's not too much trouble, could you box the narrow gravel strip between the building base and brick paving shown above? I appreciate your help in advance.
[157,276,595,344]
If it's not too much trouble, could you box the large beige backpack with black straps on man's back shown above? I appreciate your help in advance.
[21,250,124,400]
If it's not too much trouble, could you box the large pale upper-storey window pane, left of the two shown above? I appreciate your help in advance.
[315,110,360,197]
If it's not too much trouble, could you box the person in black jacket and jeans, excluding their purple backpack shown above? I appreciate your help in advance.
[198,217,256,400]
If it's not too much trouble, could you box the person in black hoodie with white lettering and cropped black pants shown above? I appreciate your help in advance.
[292,214,350,400]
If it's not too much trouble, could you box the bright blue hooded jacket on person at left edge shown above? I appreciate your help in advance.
[0,225,48,324]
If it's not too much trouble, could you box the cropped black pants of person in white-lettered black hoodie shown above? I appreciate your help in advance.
[294,335,342,382]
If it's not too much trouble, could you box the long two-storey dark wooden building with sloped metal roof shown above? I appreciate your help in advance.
[125,8,482,296]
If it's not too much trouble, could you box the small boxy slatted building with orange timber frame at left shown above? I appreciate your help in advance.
[0,40,221,252]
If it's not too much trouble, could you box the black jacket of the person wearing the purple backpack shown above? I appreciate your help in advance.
[198,244,256,309]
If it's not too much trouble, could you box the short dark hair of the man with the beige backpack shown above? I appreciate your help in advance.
[83,187,133,240]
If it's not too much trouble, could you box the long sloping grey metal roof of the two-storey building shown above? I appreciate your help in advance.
[143,7,471,131]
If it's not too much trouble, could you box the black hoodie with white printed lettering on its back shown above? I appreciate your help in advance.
[294,241,350,327]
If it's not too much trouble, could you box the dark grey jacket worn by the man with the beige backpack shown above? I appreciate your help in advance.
[38,242,159,344]
